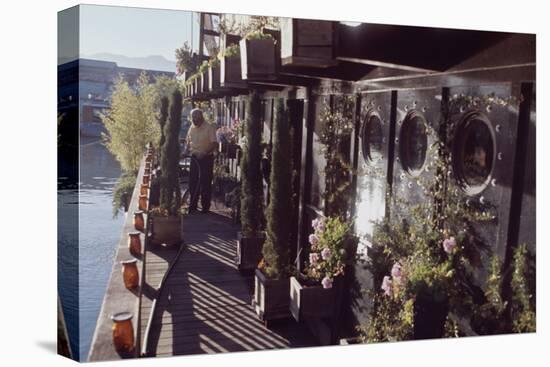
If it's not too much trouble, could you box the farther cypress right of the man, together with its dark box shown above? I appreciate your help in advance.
[236,91,265,270]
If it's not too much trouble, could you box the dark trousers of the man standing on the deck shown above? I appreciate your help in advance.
[189,155,214,211]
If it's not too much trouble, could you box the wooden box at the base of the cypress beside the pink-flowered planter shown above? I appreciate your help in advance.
[252,269,290,322]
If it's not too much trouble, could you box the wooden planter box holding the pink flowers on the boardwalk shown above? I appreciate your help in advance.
[290,277,342,321]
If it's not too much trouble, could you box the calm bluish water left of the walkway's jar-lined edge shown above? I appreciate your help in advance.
[58,138,125,360]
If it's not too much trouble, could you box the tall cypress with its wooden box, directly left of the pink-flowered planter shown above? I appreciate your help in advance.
[253,99,292,322]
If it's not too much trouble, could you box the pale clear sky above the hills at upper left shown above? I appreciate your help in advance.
[76,5,198,71]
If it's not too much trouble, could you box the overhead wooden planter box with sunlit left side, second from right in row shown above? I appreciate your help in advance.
[239,39,277,80]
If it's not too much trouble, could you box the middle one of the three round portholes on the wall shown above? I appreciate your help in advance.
[399,111,428,176]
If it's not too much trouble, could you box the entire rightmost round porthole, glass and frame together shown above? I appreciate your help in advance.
[453,111,496,195]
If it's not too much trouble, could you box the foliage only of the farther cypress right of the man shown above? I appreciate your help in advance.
[241,91,263,237]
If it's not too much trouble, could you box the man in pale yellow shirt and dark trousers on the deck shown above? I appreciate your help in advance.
[186,108,218,213]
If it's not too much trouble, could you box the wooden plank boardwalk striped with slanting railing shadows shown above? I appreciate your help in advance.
[141,210,317,356]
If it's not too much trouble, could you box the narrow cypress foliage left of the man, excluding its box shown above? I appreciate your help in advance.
[160,90,182,215]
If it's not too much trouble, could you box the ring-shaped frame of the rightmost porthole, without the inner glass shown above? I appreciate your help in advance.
[451,110,497,196]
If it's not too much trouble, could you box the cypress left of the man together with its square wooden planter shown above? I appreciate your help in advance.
[151,90,182,245]
